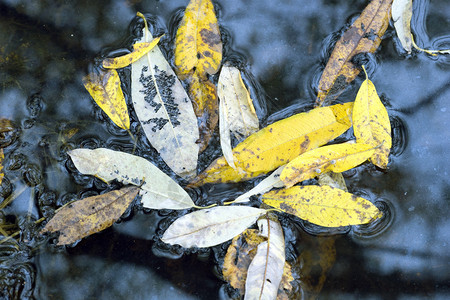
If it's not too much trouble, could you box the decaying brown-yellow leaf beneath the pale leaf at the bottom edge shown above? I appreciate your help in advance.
[222,229,294,299]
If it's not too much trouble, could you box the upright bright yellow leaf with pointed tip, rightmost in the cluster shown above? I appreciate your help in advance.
[353,69,392,169]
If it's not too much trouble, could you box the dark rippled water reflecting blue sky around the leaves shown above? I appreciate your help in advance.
[0,0,450,299]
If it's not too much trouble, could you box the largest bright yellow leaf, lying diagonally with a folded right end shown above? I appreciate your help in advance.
[191,103,353,186]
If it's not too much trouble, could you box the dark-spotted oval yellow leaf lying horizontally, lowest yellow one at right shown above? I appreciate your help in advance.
[262,185,382,227]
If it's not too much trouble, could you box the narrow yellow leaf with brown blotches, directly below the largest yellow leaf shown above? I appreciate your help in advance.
[280,143,375,187]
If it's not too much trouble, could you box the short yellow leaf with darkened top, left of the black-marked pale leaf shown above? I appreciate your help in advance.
[83,69,130,129]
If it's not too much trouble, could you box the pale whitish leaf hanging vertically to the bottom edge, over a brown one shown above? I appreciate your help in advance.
[244,218,285,299]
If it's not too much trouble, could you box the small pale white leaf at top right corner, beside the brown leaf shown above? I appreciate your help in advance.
[392,0,412,53]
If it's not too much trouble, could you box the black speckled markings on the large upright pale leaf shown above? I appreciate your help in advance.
[139,66,181,132]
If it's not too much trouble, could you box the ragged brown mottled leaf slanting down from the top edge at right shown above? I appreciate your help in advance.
[316,0,393,105]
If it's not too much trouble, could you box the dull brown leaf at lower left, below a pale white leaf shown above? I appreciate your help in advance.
[41,186,139,245]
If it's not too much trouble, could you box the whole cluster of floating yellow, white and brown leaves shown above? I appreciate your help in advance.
[36,0,450,299]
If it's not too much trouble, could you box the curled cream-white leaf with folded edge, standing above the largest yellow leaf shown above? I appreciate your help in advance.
[217,65,259,168]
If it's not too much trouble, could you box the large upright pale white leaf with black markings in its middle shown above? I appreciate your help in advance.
[131,30,199,178]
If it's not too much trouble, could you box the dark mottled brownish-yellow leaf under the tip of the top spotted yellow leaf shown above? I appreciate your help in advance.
[188,73,219,152]
